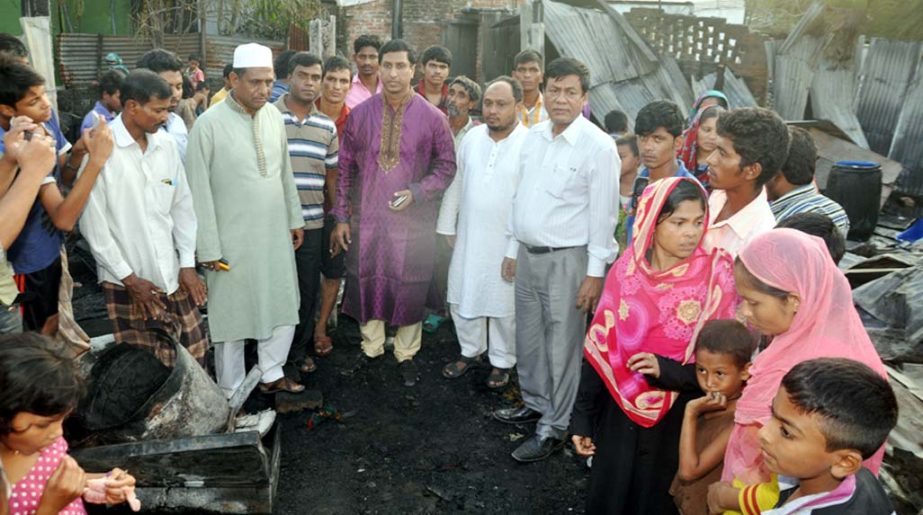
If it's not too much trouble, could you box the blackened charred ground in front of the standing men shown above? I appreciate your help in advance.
[274,316,588,514]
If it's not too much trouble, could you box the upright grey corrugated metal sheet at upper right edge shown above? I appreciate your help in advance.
[856,38,923,155]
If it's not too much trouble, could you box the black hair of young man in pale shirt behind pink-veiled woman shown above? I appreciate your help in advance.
[718,107,789,188]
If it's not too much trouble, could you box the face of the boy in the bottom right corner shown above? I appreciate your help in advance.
[759,387,841,482]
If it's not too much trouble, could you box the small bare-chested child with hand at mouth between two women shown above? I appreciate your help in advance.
[670,320,755,515]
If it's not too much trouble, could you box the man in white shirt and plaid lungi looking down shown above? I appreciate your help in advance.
[80,70,208,366]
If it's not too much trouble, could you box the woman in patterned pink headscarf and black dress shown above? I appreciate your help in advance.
[571,177,737,515]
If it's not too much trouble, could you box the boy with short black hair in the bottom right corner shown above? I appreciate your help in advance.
[708,358,897,515]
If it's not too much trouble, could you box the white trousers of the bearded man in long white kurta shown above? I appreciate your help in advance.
[449,304,516,368]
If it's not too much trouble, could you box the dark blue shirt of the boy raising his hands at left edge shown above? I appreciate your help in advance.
[0,112,71,274]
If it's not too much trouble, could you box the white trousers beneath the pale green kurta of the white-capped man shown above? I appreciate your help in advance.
[215,325,295,398]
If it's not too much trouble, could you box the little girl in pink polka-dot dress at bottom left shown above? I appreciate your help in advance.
[0,333,140,515]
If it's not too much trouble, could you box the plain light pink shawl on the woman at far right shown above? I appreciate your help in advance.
[721,229,887,484]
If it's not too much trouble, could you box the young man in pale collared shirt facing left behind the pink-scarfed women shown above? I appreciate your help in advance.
[704,107,789,256]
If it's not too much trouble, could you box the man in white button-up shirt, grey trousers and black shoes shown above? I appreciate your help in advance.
[494,57,620,462]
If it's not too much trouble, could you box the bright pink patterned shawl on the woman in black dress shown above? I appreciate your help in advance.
[584,177,737,427]
